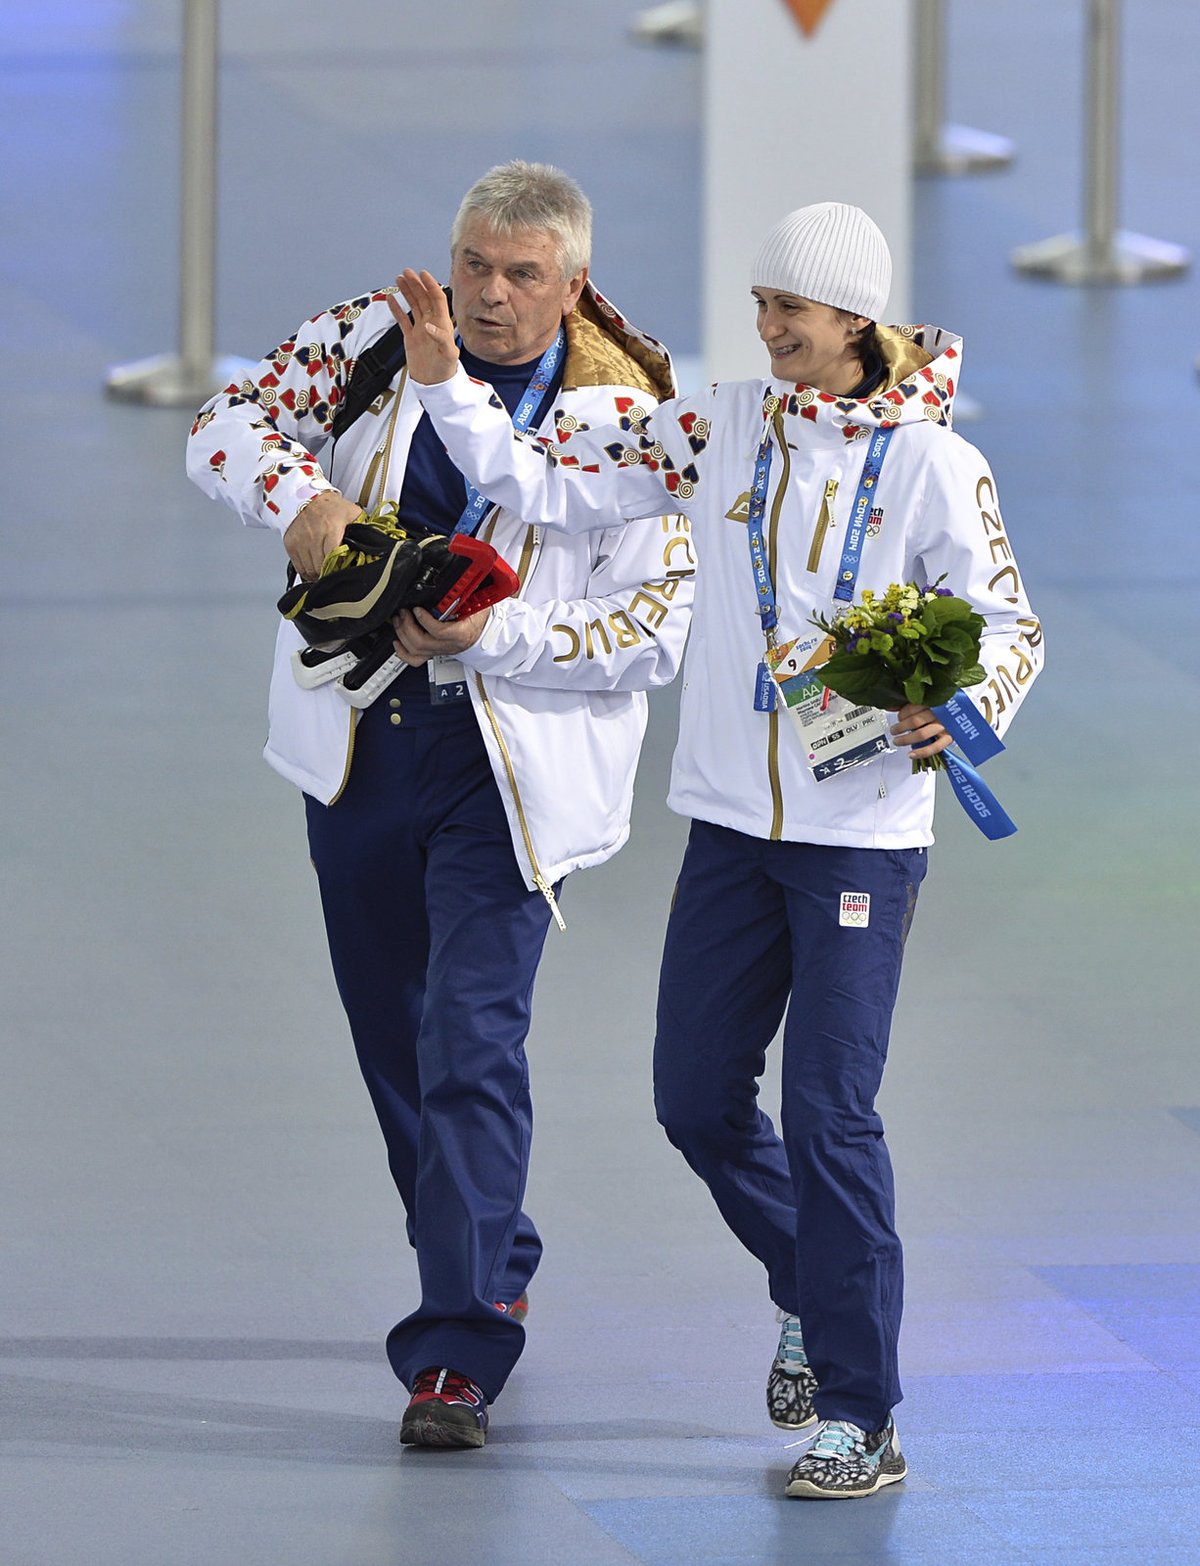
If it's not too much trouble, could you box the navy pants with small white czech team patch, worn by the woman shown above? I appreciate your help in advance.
[655,821,926,1430]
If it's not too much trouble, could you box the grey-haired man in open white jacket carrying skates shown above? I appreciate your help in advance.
[188,163,694,1447]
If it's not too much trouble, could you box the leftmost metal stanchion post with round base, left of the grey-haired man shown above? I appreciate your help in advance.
[105,0,249,407]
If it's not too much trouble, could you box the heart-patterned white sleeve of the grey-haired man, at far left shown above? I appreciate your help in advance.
[188,291,392,532]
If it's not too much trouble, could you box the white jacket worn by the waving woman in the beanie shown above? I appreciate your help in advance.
[418,327,1042,849]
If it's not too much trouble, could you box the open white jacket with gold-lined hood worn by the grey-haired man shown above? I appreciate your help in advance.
[188,287,696,904]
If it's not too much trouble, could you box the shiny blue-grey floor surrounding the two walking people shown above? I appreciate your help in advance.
[0,0,1200,1566]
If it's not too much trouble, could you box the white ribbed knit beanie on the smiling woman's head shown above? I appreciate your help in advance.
[750,200,891,321]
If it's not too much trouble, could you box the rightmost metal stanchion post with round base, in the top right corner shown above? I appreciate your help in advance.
[1012,0,1191,283]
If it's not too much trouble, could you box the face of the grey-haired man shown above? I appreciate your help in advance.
[450,216,587,365]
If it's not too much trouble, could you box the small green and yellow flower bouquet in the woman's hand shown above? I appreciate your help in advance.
[811,576,985,772]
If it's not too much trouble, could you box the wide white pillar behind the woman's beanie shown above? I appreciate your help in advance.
[702,0,913,379]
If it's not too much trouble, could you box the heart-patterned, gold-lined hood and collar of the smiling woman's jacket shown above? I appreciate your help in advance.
[769,326,962,440]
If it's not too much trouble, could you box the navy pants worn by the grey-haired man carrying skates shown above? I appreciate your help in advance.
[305,670,550,1402]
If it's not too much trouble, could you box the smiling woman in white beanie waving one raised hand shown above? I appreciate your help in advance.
[391,202,1042,1499]
